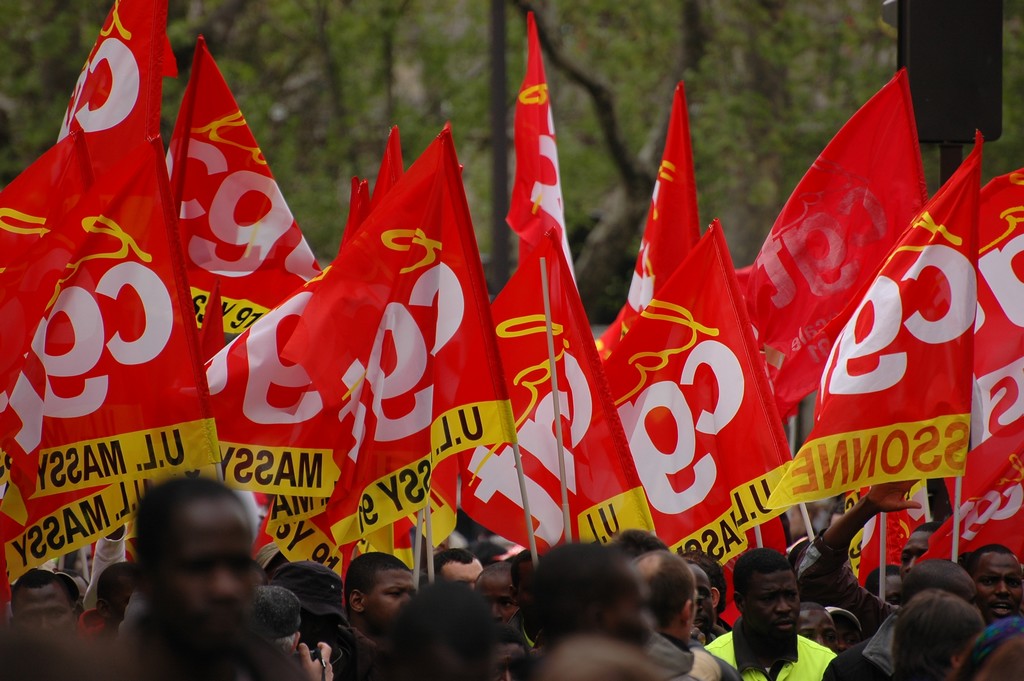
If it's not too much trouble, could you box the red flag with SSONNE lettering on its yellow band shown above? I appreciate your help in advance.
[771,135,981,506]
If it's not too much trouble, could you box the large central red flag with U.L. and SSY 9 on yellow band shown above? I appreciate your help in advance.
[282,127,515,544]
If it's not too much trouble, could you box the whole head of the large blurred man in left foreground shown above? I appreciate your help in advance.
[135,478,256,655]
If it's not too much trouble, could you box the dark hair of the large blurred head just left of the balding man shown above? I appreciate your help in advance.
[534,544,633,643]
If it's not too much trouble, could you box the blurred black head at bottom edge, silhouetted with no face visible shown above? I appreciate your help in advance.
[382,577,495,681]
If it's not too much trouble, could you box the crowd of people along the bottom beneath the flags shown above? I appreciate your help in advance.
[0,478,1024,681]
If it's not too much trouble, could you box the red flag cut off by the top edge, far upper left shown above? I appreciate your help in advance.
[58,0,177,176]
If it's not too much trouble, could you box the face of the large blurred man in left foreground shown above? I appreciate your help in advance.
[144,498,256,653]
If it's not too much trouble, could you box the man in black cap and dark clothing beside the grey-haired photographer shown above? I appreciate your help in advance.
[270,560,376,681]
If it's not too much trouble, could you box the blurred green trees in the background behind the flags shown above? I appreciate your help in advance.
[0,0,1024,323]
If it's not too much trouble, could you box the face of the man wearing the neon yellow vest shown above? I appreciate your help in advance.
[736,570,800,640]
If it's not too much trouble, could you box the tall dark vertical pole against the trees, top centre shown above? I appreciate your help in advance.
[489,0,509,294]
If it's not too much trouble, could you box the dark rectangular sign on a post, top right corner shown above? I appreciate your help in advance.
[897,0,1002,182]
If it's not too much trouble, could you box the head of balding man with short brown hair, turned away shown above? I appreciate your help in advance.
[633,551,696,641]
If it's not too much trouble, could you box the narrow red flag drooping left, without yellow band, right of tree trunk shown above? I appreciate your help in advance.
[597,83,700,358]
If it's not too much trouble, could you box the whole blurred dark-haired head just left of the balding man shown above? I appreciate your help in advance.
[534,544,648,644]
